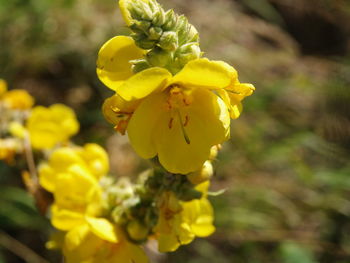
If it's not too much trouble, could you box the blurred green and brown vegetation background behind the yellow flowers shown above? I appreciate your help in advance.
[0,0,350,263]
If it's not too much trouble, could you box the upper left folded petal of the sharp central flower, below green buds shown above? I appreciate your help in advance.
[116,67,171,101]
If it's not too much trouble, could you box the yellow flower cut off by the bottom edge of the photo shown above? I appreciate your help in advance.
[63,223,148,263]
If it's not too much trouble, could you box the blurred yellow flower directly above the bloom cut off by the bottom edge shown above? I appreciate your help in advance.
[39,144,108,231]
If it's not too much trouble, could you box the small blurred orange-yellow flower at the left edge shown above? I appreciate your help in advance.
[1,89,34,110]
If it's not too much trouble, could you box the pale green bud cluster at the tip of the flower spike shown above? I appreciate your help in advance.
[121,0,201,74]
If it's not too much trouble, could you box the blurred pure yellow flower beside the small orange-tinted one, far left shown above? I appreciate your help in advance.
[26,104,79,149]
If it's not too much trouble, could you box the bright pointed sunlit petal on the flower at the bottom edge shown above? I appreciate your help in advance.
[85,217,118,243]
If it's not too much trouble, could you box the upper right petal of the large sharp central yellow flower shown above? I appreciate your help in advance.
[171,58,237,89]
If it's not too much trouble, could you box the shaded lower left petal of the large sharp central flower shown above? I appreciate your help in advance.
[127,93,166,159]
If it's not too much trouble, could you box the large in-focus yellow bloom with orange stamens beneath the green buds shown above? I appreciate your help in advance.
[97,37,253,174]
